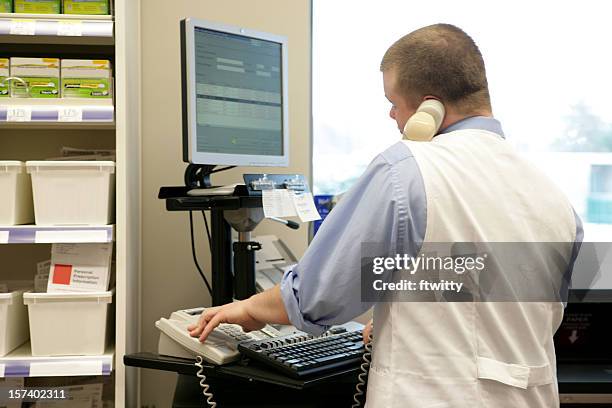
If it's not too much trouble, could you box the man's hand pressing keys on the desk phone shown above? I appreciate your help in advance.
[187,299,265,343]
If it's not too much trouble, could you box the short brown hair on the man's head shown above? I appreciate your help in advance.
[380,24,491,114]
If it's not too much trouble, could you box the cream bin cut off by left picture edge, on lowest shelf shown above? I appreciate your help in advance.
[0,289,30,357]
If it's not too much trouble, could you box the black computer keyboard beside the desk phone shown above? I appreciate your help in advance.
[238,327,364,378]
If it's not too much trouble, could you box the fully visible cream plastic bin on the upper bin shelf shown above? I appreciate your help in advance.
[26,161,115,225]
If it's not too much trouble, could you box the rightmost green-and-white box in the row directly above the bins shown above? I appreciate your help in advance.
[61,59,112,99]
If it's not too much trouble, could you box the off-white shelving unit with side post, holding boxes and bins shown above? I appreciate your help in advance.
[0,0,140,408]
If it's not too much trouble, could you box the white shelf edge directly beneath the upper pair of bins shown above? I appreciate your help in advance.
[0,225,115,244]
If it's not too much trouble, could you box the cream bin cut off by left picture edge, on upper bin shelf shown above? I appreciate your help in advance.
[0,161,34,225]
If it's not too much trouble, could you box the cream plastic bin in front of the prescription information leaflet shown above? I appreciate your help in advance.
[23,291,113,356]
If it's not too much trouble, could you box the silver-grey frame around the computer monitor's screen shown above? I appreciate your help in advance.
[181,17,289,167]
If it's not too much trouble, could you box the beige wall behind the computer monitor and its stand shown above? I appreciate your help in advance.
[140,0,311,408]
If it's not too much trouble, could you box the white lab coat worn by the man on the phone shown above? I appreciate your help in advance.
[367,130,576,408]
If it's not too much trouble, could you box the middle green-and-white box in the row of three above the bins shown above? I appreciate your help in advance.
[11,57,60,98]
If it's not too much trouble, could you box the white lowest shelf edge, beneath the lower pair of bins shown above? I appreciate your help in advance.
[0,342,115,378]
